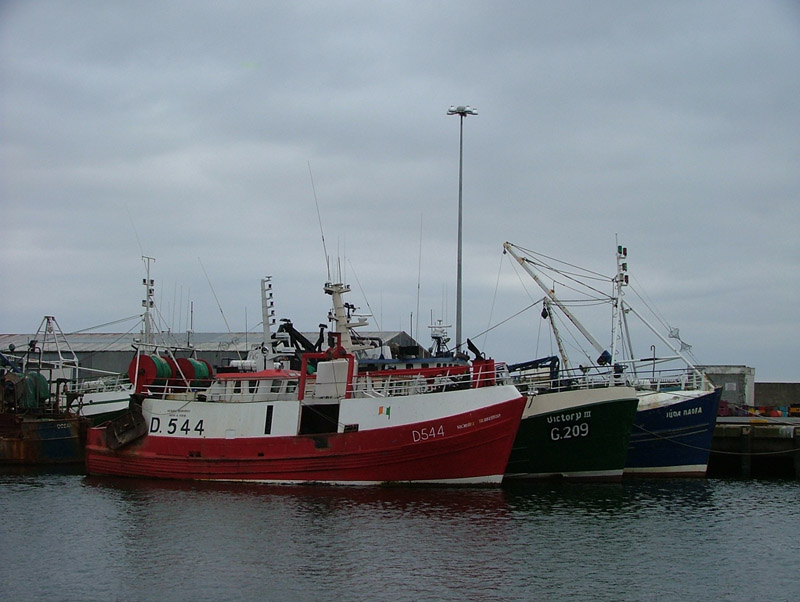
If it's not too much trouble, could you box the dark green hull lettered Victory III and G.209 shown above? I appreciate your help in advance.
[506,387,638,481]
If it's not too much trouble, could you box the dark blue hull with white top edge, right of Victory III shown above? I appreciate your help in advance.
[625,389,721,477]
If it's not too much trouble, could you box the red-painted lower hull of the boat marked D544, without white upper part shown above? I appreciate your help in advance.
[86,397,525,484]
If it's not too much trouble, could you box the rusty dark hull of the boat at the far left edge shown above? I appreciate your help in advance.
[0,414,87,466]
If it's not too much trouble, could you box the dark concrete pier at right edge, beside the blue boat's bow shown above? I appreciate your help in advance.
[708,416,800,478]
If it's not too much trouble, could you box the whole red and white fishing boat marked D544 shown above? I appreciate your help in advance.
[86,283,525,485]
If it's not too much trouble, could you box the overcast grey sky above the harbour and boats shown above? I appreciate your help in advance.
[0,0,800,382]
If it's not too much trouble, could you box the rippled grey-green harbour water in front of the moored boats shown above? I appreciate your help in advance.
[0,469,800,602]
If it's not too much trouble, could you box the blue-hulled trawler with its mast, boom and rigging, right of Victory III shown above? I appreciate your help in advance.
[504,242,721,477]
